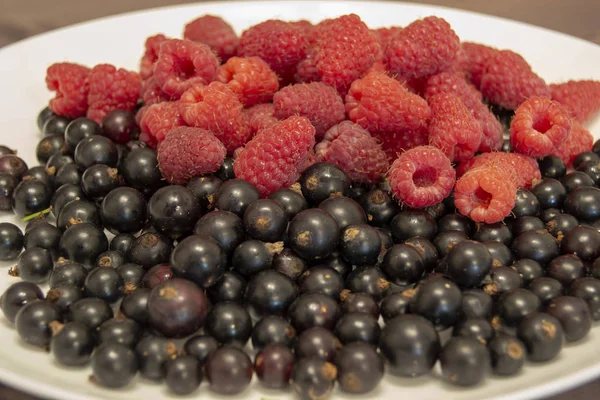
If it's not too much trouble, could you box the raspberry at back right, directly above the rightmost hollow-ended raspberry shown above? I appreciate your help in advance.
[481,50,550,110]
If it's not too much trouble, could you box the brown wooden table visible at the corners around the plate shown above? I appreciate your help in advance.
[0,0,600,400]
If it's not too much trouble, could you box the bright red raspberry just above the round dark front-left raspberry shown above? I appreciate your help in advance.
[180,82,251,154]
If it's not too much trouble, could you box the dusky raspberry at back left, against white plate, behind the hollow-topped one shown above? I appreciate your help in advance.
[183,15,239,62]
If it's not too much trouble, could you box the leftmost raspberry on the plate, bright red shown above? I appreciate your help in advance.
[46,62,90,118]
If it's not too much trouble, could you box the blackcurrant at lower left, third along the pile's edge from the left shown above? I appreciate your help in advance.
[50,322,96,366]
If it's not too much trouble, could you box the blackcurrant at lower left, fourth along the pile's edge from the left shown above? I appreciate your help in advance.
[92,343,138,388]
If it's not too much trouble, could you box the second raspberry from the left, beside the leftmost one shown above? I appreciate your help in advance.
[87,64,142,123]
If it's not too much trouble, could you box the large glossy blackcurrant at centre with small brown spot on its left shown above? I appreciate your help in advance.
[288,208,340,260]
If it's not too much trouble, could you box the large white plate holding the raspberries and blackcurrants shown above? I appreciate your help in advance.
[0,1,600,400]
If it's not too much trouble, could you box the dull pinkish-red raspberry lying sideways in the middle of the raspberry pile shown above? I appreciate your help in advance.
[273,82,345,138]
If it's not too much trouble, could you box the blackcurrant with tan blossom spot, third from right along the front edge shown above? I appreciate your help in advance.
[517,312,564,362]
